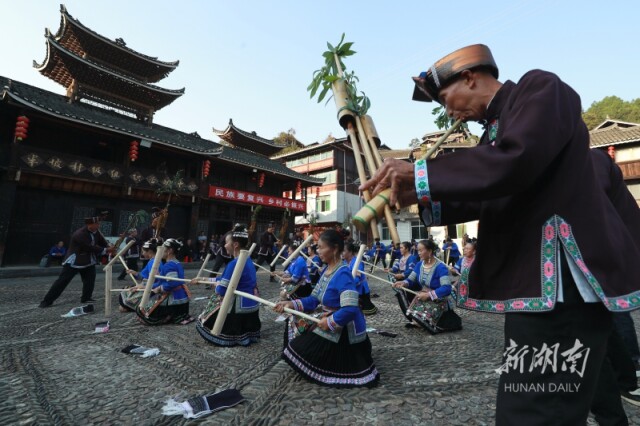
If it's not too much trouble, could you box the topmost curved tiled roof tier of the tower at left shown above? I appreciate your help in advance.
[56,5,180,82]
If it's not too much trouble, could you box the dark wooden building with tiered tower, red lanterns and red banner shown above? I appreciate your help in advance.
[0,6,321,266]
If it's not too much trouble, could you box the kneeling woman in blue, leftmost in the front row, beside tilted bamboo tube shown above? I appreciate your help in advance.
[136,238,193,325]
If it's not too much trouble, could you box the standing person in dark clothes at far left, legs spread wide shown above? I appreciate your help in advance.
[40,217,112,308]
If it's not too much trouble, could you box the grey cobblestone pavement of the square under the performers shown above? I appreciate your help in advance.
[0,270,640,426]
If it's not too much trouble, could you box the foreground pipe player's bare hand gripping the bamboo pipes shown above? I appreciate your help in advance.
[358,158,417,207]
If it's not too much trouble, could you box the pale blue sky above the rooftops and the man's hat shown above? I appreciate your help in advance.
[0,0,640,149]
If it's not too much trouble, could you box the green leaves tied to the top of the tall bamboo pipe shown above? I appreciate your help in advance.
[307,33,371,116]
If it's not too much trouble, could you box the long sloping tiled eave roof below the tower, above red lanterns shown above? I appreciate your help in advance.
[0,76,323,184]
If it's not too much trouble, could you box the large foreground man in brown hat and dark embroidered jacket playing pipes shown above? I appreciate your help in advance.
[360,45,640,425]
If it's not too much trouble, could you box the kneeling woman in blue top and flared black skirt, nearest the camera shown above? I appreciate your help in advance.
[274,229,380,387]
